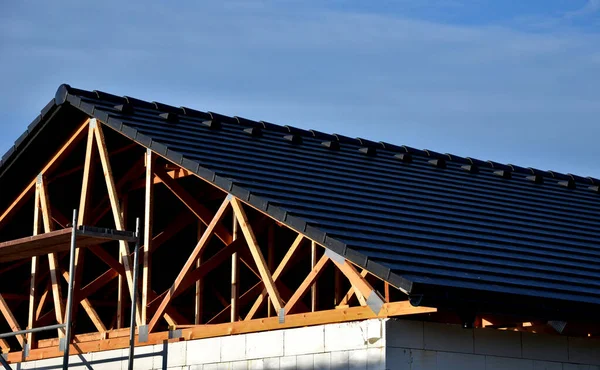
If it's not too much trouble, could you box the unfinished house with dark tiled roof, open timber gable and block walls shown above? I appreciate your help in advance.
[0,85,600,370]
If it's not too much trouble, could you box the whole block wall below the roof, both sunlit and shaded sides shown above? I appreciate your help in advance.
[13,319,600,370]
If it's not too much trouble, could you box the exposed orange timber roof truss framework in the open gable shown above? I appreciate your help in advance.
[0,119,435,362]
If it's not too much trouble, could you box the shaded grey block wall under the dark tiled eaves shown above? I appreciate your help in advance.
[385,320,600,370]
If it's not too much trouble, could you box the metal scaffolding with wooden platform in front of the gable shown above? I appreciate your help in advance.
[0,209,140,370]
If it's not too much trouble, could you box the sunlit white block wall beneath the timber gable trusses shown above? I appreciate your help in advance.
[18,320,386,370]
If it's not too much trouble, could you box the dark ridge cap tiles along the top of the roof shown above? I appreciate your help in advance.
[55,84,600,193]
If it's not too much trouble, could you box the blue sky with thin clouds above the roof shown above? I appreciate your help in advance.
[0,0,600,178]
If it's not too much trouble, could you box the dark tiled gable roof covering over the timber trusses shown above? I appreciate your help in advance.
[0,85,600,318]
